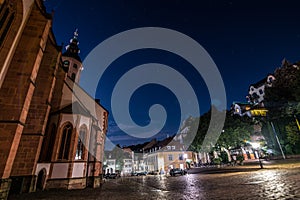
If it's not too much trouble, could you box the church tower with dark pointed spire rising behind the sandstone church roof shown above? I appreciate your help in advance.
[62,29,83,83]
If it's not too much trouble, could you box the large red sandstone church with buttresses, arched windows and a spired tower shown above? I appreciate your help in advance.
[0,0,108,199]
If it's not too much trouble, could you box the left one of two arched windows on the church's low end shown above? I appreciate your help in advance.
[58,123,73,160]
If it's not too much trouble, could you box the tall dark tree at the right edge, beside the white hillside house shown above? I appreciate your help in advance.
[264,62,300,154]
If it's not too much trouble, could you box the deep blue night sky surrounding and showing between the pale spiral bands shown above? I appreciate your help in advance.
[44,0,300,148]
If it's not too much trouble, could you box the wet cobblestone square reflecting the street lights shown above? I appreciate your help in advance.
[9,160,300,200]
